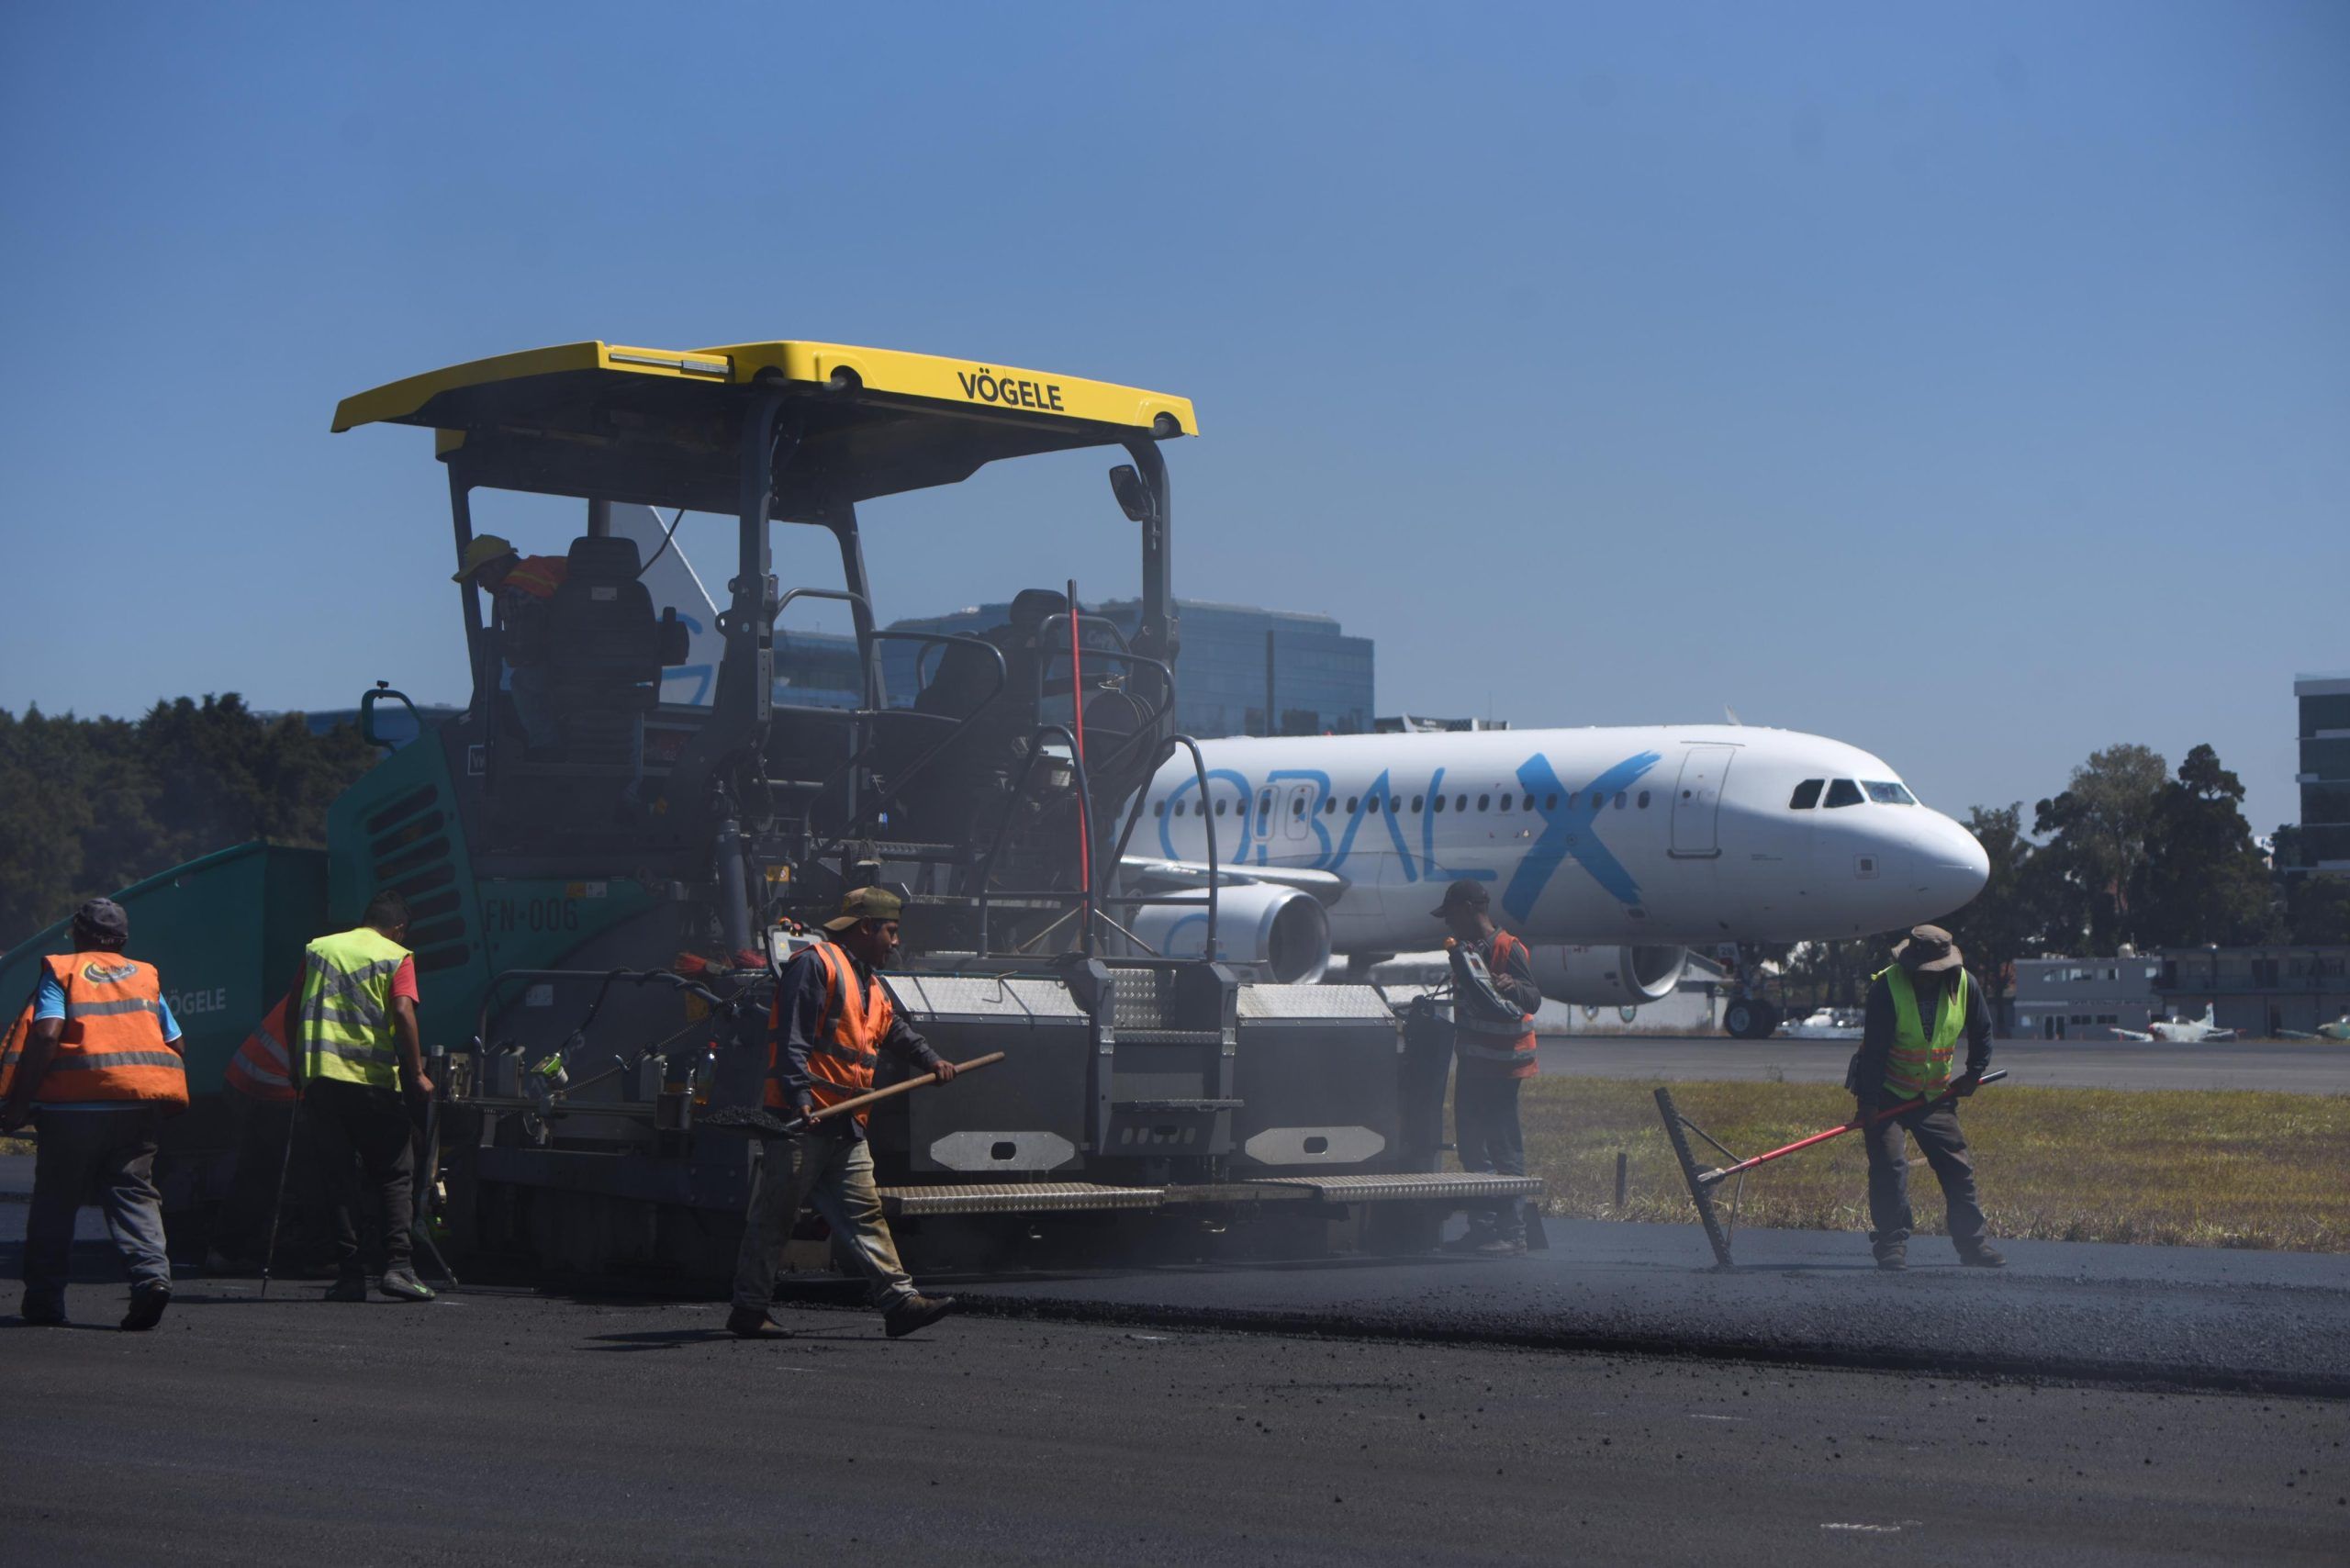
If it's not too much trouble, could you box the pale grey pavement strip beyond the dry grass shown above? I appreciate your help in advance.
[1541,1035,2350,1095]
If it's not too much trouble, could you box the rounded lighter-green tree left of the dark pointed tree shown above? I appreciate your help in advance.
[2032,743,2169,952]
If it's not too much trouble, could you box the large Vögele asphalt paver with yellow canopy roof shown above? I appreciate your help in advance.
[5,343,1530,1274]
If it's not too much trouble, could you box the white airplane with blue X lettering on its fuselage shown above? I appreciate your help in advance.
[1121,724,1990,1006]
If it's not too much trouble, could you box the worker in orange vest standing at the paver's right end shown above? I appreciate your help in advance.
[1431,879,1541,1258]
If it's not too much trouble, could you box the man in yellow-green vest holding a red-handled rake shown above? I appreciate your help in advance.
[1850,926,2007,1270]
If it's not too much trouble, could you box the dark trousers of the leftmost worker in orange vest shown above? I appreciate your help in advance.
[24,1110,172,1307]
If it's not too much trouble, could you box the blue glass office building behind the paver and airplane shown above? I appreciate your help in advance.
[881,599,1372,738]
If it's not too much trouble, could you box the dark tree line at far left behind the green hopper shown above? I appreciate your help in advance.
[0,691,376,950]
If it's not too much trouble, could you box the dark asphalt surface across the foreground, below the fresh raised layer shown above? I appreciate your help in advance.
[0,1282,2350,1568]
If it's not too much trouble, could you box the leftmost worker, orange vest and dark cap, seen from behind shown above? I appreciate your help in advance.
[0,898,188,1328]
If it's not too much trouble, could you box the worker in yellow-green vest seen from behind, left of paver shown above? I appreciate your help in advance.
[289,891,432,1303]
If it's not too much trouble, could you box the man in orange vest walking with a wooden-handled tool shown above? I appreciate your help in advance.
[726,886,954,1340]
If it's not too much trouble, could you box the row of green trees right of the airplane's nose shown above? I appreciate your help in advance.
[1784,745,2350,1006]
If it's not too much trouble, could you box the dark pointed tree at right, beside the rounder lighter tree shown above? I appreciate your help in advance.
[2136,745,2277,947]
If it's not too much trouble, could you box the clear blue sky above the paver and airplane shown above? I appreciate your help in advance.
[0,3,2350,830]
